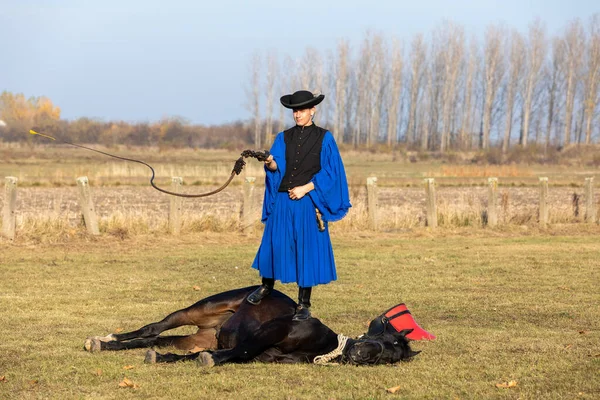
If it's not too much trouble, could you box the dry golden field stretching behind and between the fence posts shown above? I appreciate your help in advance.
[0,144,600,242]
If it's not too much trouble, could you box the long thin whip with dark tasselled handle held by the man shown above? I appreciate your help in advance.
[29,128,271,197]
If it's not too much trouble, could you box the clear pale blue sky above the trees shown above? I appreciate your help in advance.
[0,0,600,124]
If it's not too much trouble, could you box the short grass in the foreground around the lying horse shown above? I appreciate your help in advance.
[0,230,600,399]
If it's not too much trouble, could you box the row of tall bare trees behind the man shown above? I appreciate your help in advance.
[247,14,600,153]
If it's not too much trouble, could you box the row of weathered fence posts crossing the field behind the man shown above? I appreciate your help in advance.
[1,176,598,240]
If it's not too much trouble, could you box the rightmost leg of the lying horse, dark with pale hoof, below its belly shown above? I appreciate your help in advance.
[197,317,291,367]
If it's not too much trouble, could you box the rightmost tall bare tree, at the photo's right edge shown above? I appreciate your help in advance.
[584,14,600,144]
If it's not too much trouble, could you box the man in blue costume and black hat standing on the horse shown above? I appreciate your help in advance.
[248,90,351,320]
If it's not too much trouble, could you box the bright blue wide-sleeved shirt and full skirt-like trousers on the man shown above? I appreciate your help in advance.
[252,131,351,287]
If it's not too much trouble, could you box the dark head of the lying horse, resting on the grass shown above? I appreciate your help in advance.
[344,329,420,365]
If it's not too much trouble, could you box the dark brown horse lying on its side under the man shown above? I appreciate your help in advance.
[84,286,419,366]
